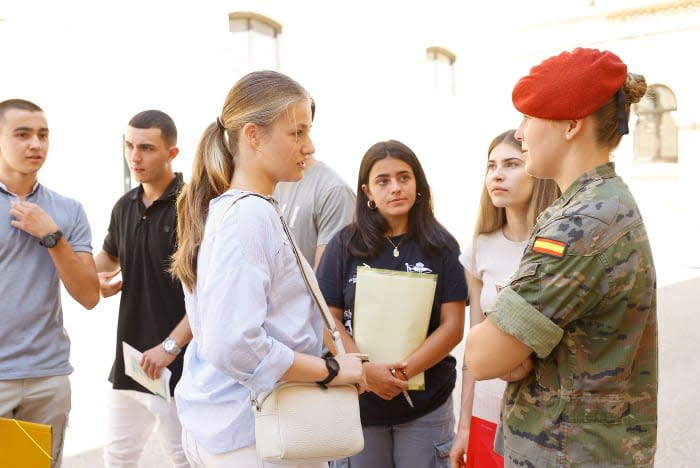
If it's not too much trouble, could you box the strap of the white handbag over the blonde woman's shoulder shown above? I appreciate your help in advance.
[219,192,345,355]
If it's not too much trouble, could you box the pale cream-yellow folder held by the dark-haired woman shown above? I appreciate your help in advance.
[352,266,437,390]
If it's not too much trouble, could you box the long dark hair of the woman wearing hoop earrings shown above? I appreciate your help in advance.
[346,140,459,258]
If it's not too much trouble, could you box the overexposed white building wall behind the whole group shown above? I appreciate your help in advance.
[0,0,700,265]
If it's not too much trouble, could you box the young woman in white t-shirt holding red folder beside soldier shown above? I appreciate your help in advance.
[450,130,560,468]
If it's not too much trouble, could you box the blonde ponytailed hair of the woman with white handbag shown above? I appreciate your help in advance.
[170,71,311,291]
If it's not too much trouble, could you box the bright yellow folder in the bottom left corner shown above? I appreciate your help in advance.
[0,418,51,468]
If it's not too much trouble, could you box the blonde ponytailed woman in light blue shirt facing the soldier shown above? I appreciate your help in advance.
[172,71,364,468]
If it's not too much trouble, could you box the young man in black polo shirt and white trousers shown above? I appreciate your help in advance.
[95,110,192,468]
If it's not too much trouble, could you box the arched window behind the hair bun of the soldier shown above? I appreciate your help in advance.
[633,84,678,163]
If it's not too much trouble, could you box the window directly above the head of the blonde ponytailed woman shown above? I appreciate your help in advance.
[228,11,282,73]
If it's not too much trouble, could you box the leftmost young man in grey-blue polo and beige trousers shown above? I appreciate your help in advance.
[0,99,99,467]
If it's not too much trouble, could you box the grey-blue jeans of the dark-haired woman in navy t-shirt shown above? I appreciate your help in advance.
[330,397,455,468]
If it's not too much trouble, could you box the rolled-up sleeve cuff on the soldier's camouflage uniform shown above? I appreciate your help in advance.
[488,288,564,358]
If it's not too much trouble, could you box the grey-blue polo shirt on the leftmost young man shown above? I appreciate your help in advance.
[0,183,92,380]
